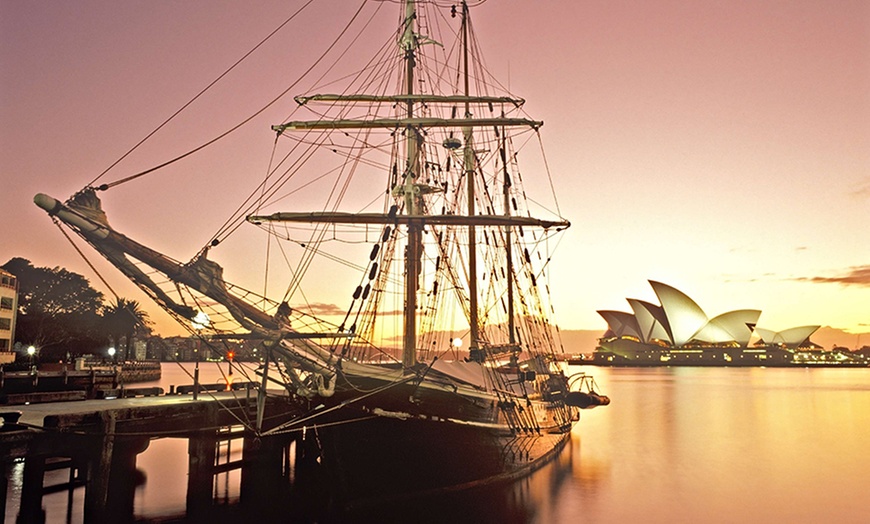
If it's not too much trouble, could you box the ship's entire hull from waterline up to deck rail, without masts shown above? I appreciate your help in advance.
[304,368,570,509]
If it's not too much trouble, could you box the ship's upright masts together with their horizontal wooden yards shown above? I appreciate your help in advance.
[247,0,570,362]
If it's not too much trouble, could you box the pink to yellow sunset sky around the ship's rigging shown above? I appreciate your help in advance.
[0,0,870,342]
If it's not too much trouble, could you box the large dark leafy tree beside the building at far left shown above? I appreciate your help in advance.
[3,257,107,360]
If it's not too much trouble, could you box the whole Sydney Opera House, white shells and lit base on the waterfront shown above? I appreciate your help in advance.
[595,281,860,366]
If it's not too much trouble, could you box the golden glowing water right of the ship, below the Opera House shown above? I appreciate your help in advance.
[557,368,870,522]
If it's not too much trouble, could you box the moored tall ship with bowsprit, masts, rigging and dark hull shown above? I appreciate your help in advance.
[35,1,609,504]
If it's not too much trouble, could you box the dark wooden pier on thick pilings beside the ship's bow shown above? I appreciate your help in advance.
[0,388,314,523]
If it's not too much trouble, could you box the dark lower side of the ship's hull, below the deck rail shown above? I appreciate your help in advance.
[317,410,569,509]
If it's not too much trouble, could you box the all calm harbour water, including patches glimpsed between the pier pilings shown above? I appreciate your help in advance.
[6,364,870,524]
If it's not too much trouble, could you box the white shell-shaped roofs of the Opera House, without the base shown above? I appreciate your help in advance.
[598,280,819,347]
